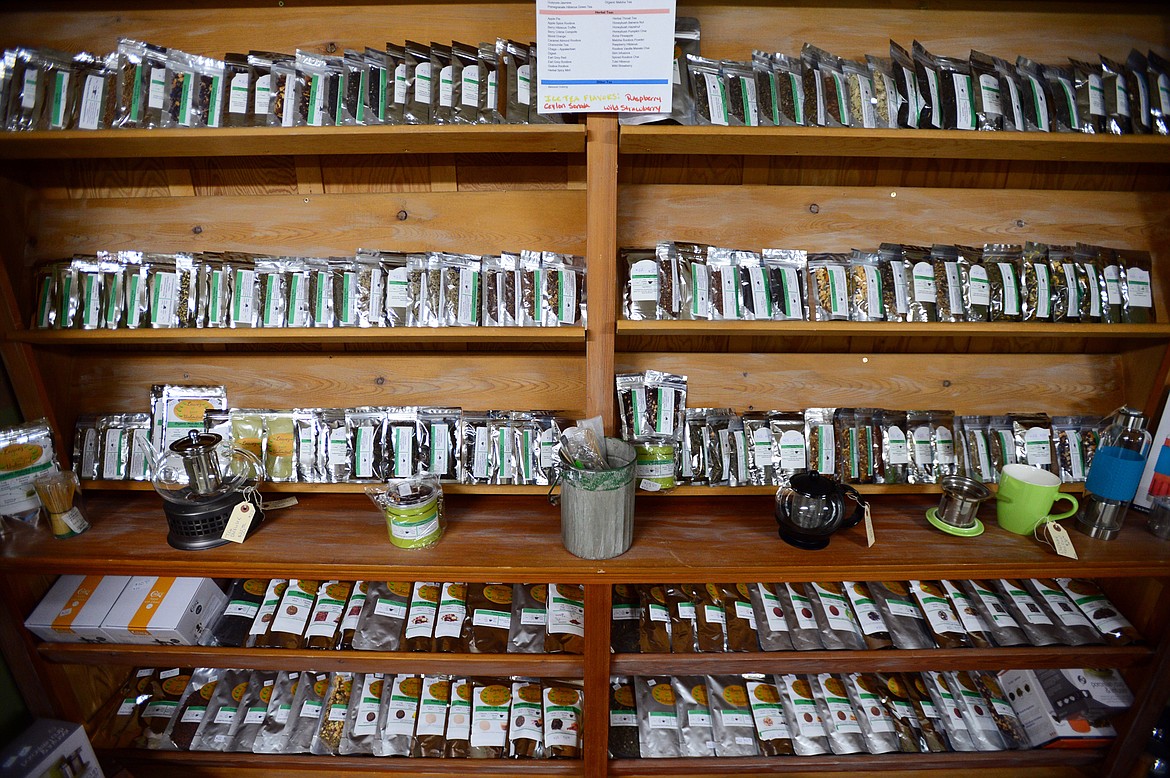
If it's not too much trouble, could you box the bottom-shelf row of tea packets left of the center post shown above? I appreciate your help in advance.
[94,668,584,759]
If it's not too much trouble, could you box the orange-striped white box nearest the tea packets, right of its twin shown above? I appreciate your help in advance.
[102,576,227,646]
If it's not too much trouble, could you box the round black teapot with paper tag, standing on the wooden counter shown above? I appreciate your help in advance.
[776,470,865,550]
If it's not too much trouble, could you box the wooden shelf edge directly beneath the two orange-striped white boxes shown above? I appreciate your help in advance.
[37,642,585,679]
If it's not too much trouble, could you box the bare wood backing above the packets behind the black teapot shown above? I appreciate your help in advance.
[617,352,1127,414]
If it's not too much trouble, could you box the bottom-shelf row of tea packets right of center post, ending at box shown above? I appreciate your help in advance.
[608,669,1133,758]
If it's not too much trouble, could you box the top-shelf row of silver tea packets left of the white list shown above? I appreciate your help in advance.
[0,39,564,130]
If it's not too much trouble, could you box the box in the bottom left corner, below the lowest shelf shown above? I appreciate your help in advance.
[0,718,104,778]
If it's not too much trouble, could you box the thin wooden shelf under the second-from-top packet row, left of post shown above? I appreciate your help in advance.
[6,326,585,349]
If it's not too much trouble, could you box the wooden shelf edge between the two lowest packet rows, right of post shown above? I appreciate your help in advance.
[610,646,1154,675]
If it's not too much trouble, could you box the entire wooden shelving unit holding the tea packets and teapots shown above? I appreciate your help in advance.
[0,0,1170,778]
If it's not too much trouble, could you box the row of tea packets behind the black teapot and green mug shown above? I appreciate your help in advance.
[615,370,1100,489]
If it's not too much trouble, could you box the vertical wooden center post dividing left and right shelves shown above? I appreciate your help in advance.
[581,113,618,778]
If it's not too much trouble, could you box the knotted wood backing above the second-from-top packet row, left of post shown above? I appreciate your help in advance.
[34,191,585,259]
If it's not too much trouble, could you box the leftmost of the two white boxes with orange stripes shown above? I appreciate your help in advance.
[25,576,130,643]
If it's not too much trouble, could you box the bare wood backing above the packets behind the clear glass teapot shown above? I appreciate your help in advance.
[59,352,585,416]
